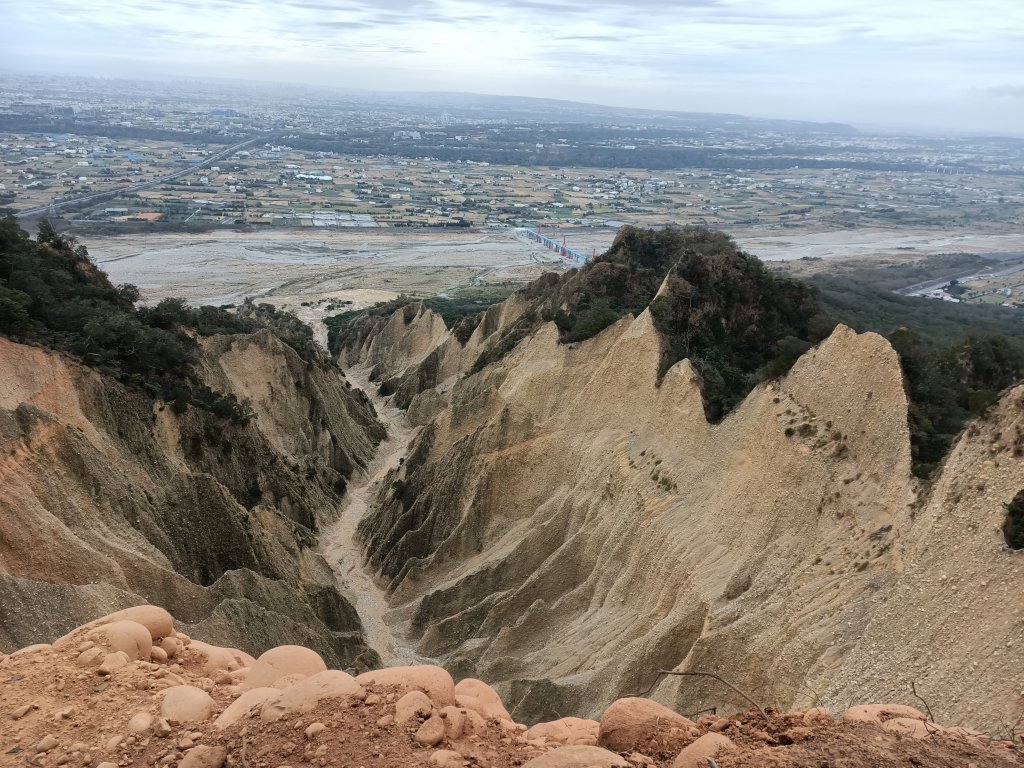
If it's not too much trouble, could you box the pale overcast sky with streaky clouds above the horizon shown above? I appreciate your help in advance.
[0,0,1024,135]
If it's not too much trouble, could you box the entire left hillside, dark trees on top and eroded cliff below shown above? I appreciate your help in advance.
[0,221,384,667]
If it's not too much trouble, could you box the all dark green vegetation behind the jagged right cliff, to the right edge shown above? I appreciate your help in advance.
[329,226,1024,477]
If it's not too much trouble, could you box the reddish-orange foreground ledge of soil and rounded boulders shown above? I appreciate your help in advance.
[0,606,1022,768]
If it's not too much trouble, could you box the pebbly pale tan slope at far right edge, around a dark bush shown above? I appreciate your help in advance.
[830,386,1024,732]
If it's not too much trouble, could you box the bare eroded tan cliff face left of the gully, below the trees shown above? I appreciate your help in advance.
[0,332,384,668]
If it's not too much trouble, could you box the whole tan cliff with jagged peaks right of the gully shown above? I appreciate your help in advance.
[339,296,1024,728]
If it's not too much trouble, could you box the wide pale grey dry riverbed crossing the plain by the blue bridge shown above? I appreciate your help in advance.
[86,227,1024,326]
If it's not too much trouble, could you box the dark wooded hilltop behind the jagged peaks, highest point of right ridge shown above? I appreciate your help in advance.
[329,226,835,421]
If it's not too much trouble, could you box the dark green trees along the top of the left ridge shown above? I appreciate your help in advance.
[0,216,316,421]
